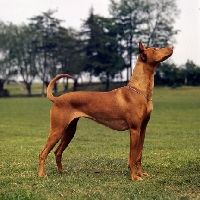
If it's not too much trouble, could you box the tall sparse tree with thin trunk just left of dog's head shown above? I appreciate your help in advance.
[110,0,149,81]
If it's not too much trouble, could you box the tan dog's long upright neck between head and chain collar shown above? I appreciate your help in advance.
[128,59,157,99]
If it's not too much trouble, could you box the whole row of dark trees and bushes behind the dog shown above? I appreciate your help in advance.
[0,0,200,95]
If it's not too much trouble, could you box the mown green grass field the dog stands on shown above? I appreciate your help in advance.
[0,87,200,200]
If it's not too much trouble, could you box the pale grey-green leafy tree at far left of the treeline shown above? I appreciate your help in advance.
[2,24,37,96]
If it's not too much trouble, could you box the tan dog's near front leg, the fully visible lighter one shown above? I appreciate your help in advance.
[128,128,142,180]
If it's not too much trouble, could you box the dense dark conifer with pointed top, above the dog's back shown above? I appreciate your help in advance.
[84,10,124,90]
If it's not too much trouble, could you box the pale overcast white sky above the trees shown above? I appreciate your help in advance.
[0,0,200,66]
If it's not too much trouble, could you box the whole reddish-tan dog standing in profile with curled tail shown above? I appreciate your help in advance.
[39,43,173,180]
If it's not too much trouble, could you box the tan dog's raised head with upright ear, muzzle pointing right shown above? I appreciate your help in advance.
[139,42,173,64]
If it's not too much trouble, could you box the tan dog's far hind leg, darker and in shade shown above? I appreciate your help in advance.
[54,118,79,173]
